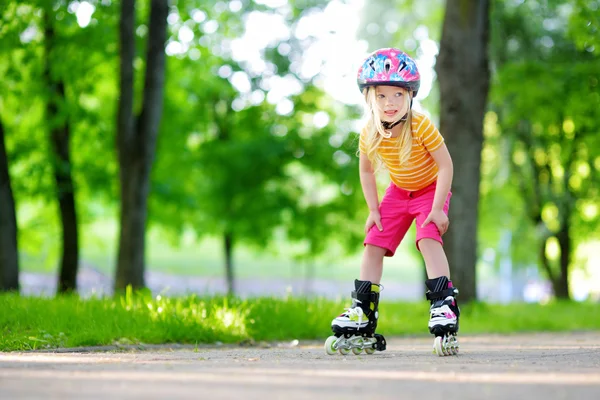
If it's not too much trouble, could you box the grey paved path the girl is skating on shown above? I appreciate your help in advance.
[0,332,600,400]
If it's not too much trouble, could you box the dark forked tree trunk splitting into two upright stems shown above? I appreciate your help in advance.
[115,0,169,291]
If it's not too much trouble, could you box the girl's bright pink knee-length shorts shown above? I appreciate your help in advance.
[364,182,452,257]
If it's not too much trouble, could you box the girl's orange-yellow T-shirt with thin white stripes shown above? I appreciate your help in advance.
[359,113,444,192]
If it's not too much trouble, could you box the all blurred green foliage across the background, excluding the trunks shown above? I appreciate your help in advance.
[0,0,600,294]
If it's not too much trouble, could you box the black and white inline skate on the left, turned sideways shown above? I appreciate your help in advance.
[325,279,386,354]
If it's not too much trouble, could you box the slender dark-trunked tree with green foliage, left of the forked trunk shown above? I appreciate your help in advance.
[0,0,117,291]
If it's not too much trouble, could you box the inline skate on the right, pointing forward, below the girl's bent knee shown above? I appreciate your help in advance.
[425,276,460,356]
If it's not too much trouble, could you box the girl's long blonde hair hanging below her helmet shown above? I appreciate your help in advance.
[363,86,413,171]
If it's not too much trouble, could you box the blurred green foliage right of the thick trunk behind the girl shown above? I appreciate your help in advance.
[480,1,600,278]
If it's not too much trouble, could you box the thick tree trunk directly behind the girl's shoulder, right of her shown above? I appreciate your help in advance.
[436,0,490,301]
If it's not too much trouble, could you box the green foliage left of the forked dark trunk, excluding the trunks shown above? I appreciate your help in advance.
[0,1,118,272]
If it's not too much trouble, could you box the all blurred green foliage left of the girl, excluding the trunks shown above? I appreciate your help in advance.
[0,0,370,278]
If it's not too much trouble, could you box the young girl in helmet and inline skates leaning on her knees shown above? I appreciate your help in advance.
[325,48,460,356]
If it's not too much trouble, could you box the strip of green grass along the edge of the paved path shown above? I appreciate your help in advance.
[0,293,600,351]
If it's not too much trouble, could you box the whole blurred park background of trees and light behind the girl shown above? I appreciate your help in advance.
[0,0,600,302]
